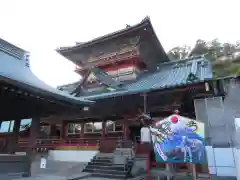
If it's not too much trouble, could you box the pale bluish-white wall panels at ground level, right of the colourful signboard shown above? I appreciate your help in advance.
[206,146,237,177]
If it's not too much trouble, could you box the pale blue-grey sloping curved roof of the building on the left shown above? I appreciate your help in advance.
[0,45,92,104]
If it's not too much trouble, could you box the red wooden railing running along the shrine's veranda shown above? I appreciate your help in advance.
[0,137,151,154]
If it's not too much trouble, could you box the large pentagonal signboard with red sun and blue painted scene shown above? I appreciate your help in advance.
[150,115,206,163]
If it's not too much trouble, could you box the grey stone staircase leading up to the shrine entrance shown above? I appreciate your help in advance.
[83,148,134,179]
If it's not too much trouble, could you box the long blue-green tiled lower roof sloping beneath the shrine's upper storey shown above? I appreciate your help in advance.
[76,57,212,100]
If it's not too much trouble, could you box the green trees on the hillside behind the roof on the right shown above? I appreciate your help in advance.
[167,39,240,77]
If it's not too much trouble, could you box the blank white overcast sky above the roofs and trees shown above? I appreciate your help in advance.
[0,0,240,87]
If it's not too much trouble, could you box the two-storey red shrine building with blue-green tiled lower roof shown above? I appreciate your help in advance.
[0,17,236,177]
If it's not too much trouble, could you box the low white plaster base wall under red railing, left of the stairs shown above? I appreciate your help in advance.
[48,150,98,162]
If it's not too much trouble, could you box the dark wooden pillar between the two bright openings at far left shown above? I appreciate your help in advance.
[8,119,21,154]
